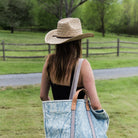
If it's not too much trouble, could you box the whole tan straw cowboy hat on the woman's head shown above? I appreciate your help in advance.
[45,18,94,44]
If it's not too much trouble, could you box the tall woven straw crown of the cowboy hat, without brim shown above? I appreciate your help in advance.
[56,18,82,37]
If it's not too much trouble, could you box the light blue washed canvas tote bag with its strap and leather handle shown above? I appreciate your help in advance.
[42,59,109,138]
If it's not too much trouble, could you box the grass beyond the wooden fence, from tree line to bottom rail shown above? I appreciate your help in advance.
[0,30,138,56]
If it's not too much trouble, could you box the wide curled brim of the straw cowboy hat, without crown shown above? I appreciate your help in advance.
[45,29,94,44]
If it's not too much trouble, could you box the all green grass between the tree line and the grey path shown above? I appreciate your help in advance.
[0,30,138,74]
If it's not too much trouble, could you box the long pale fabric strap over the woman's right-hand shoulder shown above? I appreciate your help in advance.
[69,58,84,99]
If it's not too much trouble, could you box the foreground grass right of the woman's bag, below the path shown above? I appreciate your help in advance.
[96,77,138,138]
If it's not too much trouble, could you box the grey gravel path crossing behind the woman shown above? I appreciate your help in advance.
[0,67,138,87]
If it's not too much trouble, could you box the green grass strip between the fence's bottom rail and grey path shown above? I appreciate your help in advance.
[0,55,138,74]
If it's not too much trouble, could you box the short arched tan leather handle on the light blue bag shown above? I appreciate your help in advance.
[71,88,90,111]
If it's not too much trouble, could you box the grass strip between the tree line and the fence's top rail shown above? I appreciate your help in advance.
[0,30,138,43]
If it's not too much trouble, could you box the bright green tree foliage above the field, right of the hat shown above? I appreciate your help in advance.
[73,0,138,35]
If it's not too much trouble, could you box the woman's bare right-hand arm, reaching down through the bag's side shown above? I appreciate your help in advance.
[81,59,102,110]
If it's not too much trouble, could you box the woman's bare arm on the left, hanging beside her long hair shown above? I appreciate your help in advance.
[40,58,50,101]
